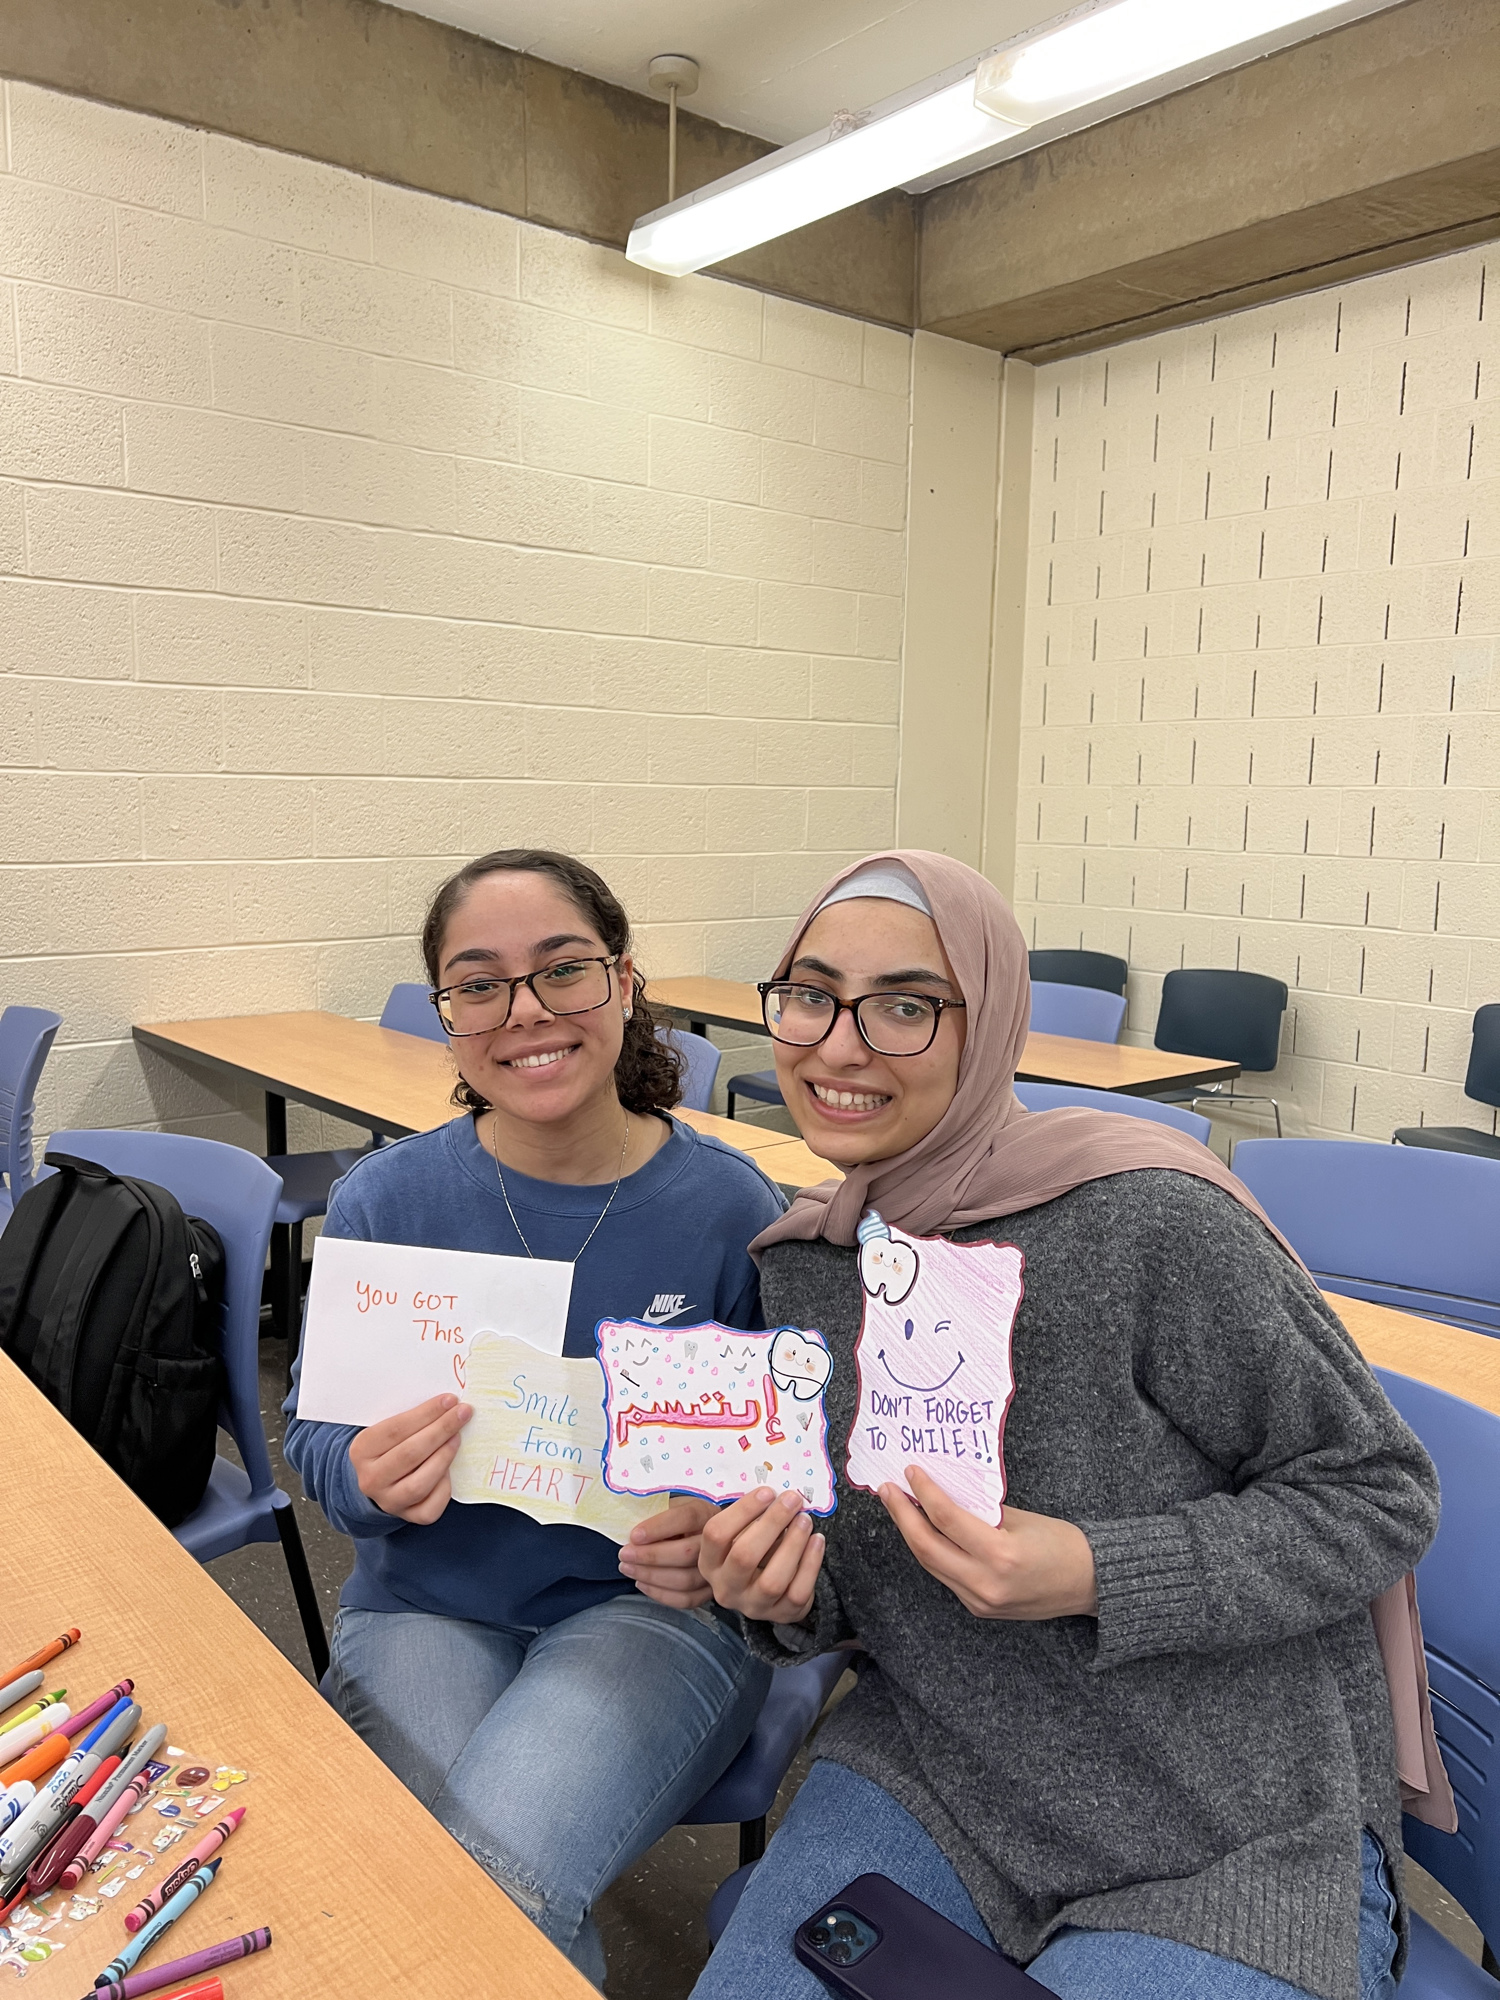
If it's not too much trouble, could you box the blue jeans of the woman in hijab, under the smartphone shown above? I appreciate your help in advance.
[692,1762,1396,2000]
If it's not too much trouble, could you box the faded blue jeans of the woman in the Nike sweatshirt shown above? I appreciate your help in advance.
[330,1592,770,1986]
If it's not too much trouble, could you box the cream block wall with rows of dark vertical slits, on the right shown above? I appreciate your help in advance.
[1016,248,1500,1140]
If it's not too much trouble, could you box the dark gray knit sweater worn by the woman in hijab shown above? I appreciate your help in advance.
[748,1170,1438,2000]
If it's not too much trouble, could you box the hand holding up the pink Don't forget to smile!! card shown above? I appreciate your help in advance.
[880,1466,1098,1618]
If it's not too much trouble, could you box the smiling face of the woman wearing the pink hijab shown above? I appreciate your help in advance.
[772,896,964,1166]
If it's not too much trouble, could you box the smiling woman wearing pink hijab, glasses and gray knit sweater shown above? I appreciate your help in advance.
[694,852,1438,2000]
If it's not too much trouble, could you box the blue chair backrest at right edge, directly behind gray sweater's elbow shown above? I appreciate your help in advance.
[1376,1368,1500,1950]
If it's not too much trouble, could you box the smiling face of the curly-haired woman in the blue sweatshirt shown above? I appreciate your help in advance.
[438,870,630,1124]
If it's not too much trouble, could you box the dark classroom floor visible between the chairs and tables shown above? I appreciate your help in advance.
[208,1340,1482,2000]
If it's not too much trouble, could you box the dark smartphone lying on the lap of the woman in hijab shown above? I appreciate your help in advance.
[792,1874,1050,2000]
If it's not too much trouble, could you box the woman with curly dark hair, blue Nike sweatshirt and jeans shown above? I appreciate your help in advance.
[286,848,782,1986]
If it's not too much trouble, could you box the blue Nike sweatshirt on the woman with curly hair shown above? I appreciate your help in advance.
[286,1116,784,1628]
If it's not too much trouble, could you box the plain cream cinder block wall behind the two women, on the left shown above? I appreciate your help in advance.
[0,82,910,1144]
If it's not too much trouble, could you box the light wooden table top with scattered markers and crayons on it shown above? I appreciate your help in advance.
[0,1356,594,2000]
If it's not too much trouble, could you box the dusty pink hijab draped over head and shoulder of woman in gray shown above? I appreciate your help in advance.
[750,848,1458,1832]
